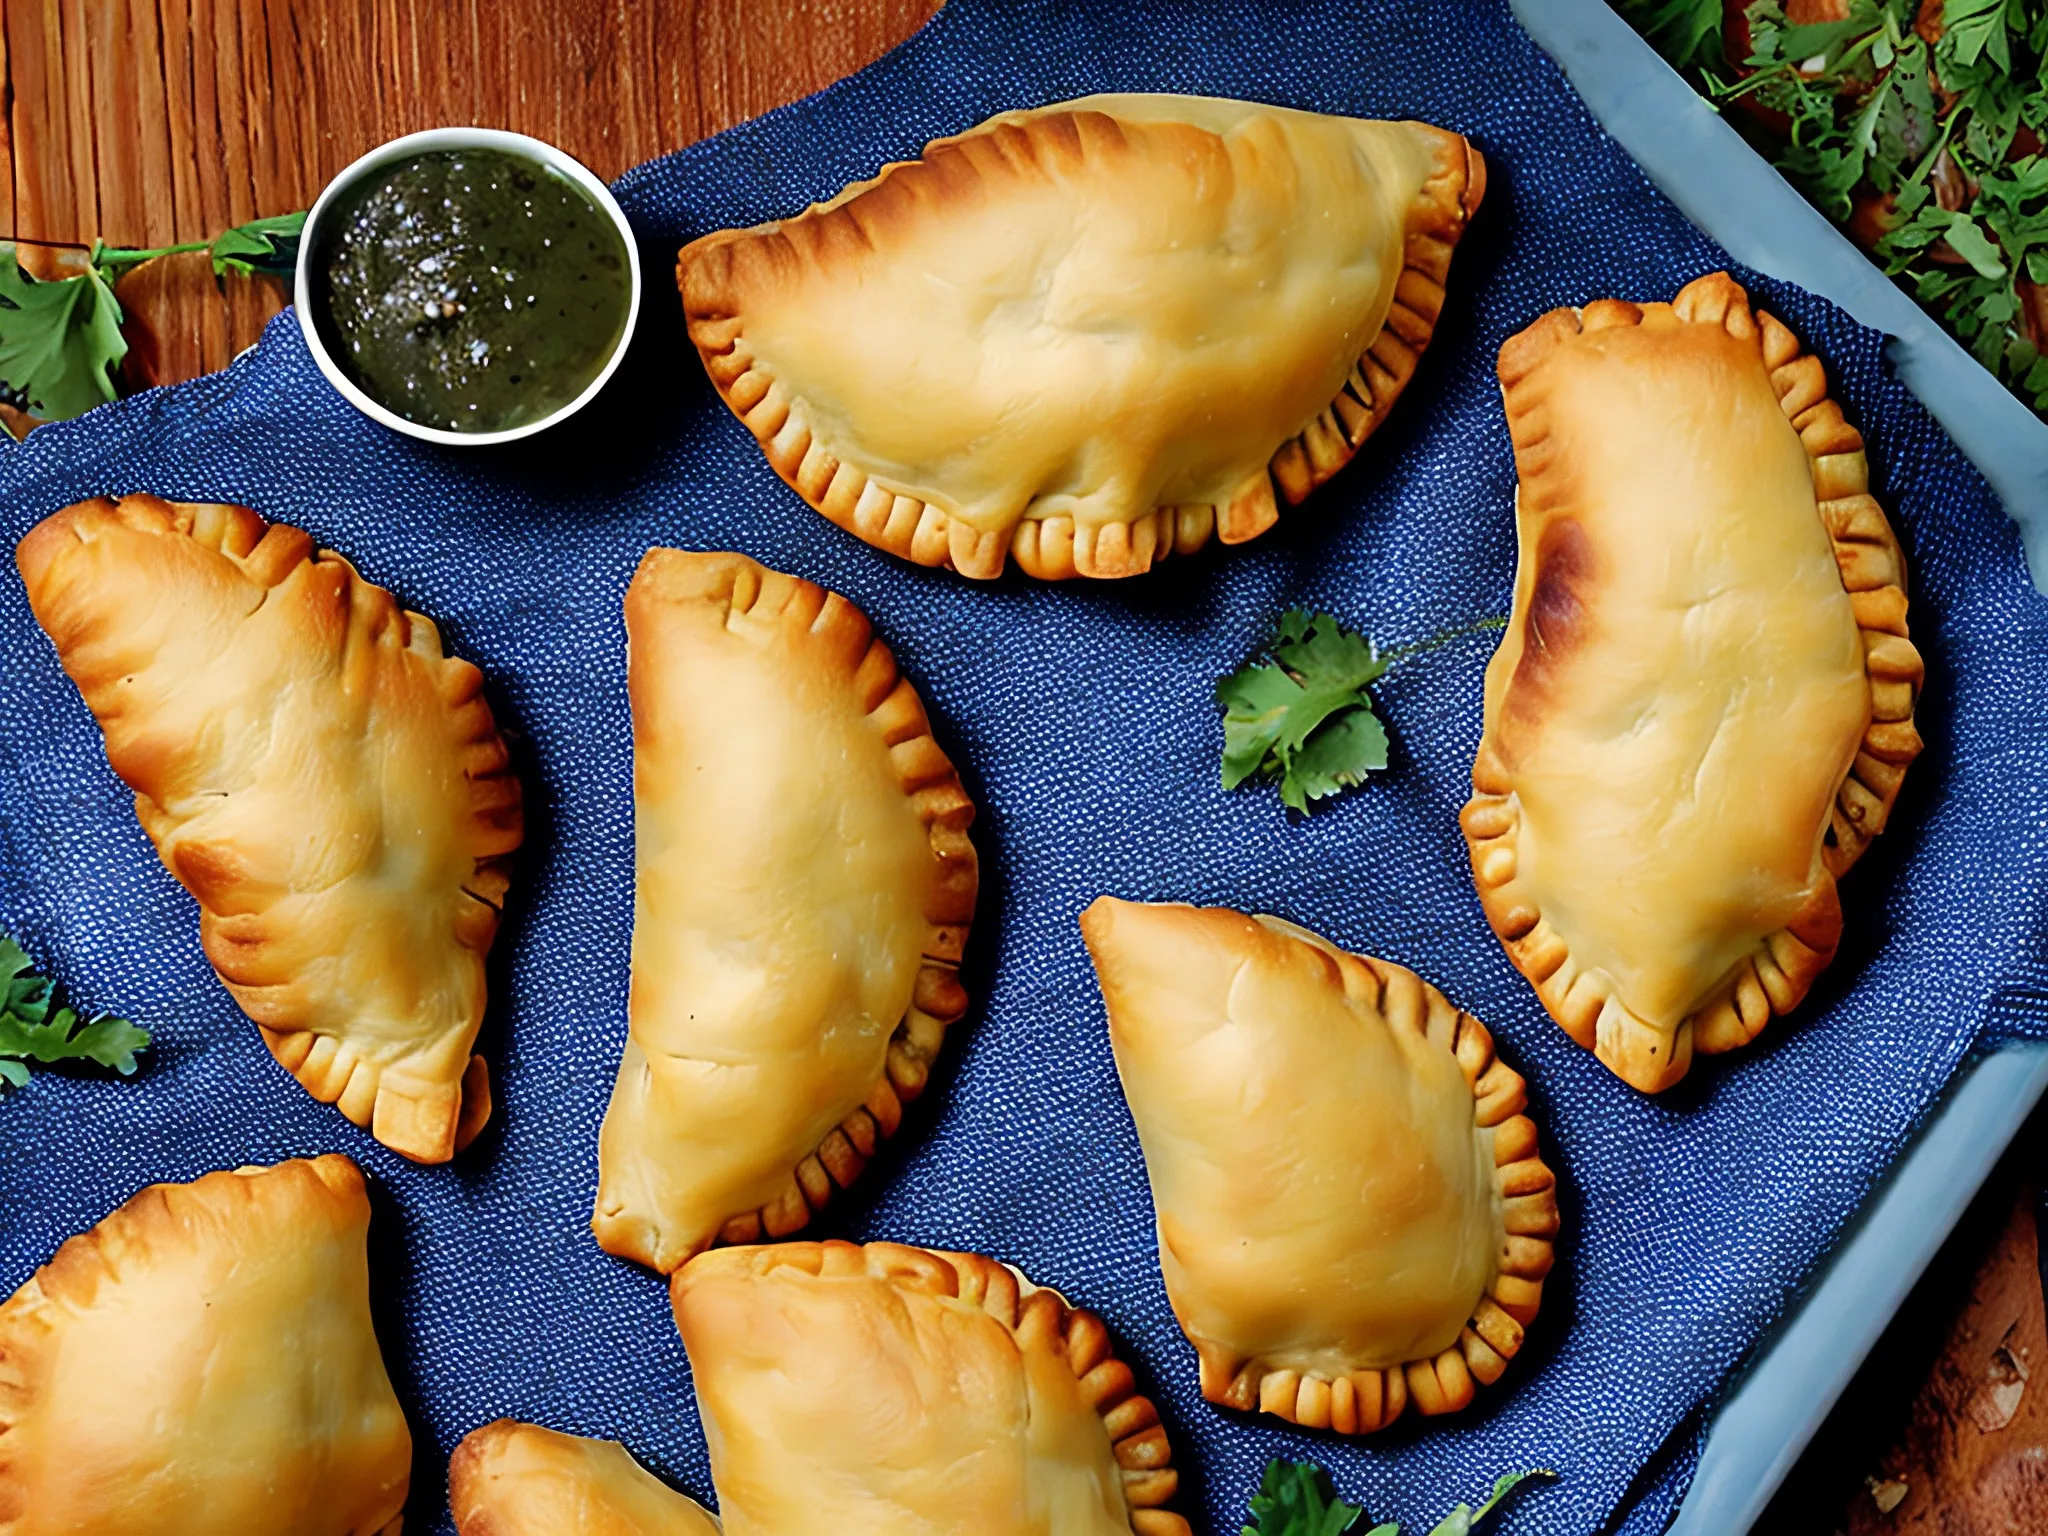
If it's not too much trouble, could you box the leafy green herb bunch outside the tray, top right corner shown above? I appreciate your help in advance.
[1614,0,2048,414]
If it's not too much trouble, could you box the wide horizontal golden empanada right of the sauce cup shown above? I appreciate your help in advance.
[676,96,1485,578]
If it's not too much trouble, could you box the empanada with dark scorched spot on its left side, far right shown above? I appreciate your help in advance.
[1462,272,1923,1094]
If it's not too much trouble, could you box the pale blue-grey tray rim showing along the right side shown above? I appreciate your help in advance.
[1511,0,2048,1536]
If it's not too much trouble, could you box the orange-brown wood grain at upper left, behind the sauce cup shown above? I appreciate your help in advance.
[0,0,936,385]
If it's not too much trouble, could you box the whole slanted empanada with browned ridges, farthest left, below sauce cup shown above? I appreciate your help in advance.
[14,496,522,1163]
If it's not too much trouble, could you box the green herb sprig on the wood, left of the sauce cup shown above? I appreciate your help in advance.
[0,213,305,438]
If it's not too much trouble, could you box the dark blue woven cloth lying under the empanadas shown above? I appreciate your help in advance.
[0,0,2048,1536]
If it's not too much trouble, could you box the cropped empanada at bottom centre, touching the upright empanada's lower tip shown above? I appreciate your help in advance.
[670,1243,1190,1536]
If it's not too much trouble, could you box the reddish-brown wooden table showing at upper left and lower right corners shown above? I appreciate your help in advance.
[0,0,2048,1536]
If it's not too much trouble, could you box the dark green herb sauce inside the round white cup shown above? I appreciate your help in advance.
[313,150,633,432]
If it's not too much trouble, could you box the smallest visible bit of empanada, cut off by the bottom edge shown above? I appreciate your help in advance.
[449,1419,719,1536]
